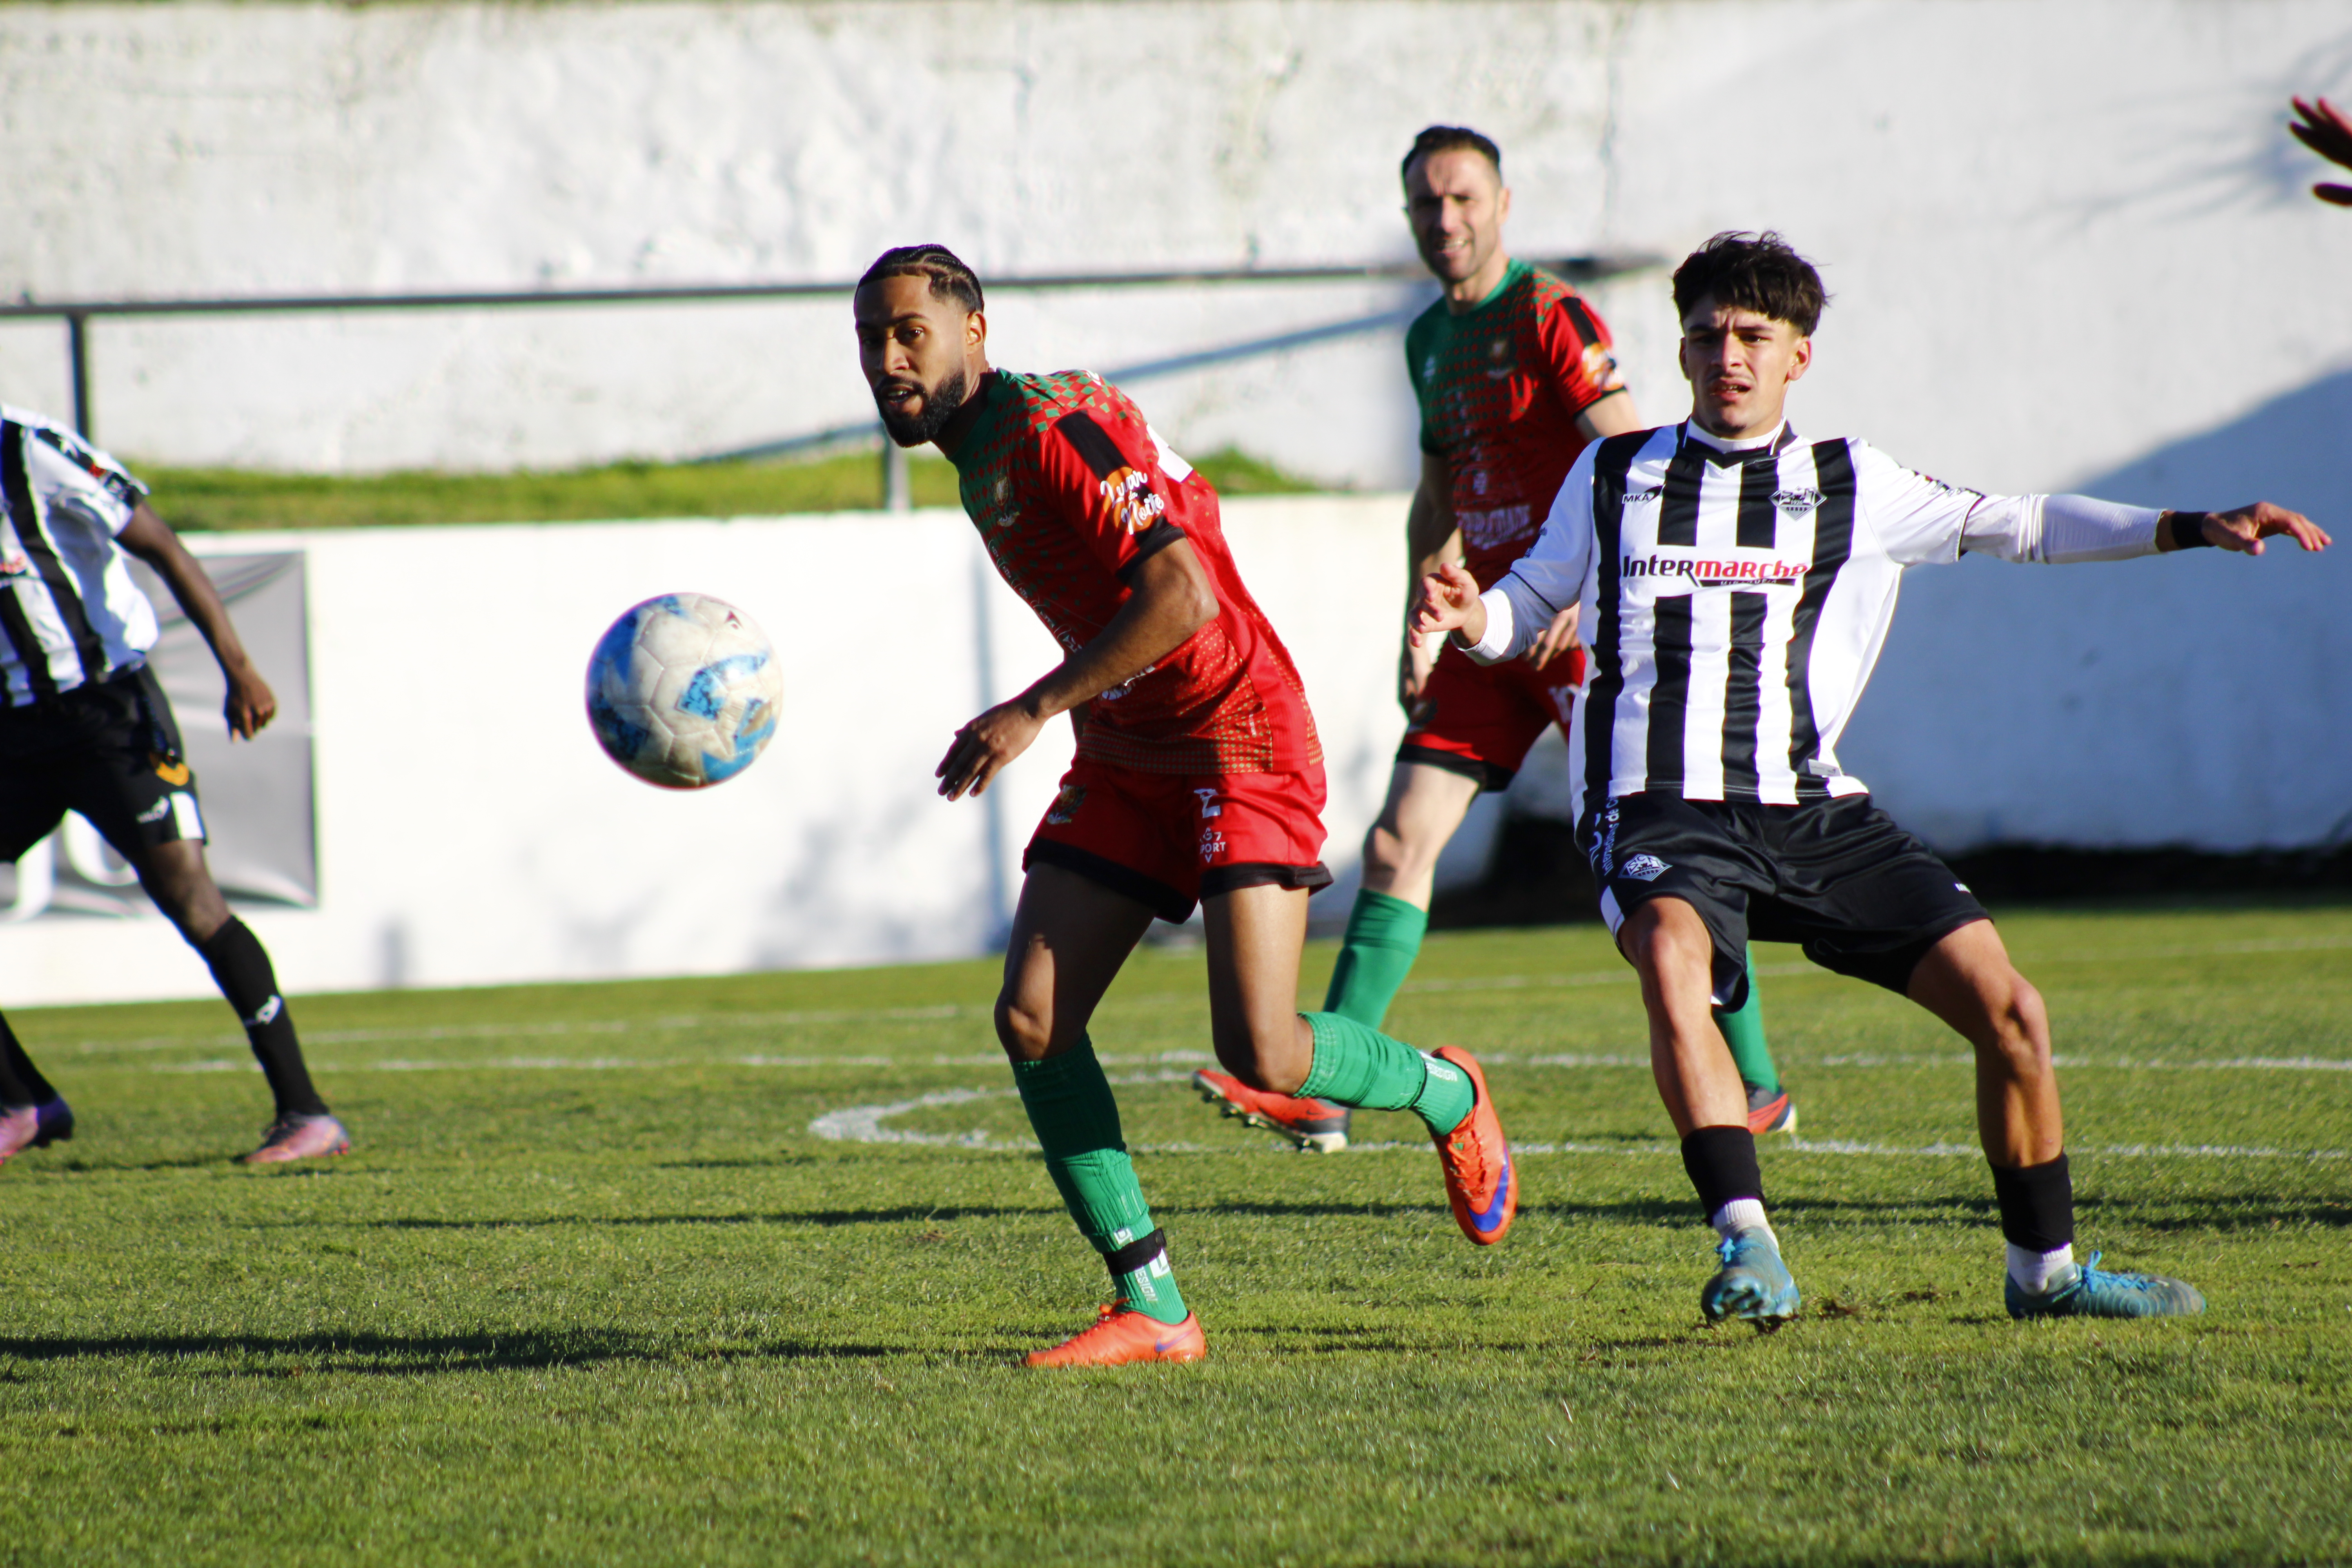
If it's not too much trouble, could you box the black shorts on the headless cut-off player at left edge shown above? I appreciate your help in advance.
[0,668,205,860]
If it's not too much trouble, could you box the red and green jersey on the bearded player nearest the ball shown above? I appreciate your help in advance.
[955,372,1322,773]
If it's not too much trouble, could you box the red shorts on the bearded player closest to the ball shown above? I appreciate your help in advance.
[1021,757,1331,922]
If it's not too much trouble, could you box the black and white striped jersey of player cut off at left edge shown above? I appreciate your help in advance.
[0,404,155,708]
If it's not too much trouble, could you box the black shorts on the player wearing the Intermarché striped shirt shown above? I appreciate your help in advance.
[1576,795,1990,1006]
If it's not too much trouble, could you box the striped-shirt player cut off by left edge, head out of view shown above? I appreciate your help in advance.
[0,407,350,1164]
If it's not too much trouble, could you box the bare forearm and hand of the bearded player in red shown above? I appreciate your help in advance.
[934,543,1216,799]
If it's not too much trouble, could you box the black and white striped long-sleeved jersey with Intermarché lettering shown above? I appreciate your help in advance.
[1470,421,2157,816]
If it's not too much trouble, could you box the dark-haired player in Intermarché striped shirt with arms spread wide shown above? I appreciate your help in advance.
[1416,235,2328,1328]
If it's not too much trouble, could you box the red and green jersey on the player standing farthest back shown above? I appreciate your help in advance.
[1404,261,1625,588]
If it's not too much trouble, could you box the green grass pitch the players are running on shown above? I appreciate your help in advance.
[0,907,2352,1563]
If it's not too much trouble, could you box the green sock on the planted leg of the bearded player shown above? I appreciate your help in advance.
[1014,1037,1185,1323]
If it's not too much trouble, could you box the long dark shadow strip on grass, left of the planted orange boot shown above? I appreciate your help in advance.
[0,1330,894,1375]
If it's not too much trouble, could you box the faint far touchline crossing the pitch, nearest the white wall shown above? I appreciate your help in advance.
[60,936,2352,1060]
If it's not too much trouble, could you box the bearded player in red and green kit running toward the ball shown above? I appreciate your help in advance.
[854,245,1517,1366]
